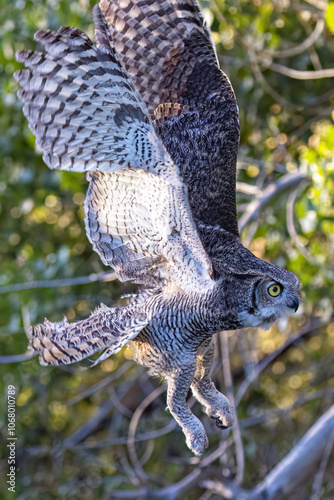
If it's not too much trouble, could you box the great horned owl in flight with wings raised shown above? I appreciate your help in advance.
[15,0,299,455]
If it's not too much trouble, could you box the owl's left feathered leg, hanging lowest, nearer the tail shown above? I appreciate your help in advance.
[167,360,209,455]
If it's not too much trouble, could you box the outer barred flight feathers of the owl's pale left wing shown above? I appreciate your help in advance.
[15,28,168,172]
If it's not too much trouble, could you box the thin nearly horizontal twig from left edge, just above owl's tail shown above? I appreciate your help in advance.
[0,271,117,295]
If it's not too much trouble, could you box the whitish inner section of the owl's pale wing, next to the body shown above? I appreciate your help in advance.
[85,169,213,291]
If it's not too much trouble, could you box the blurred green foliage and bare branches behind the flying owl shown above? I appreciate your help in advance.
[0,0,334,500]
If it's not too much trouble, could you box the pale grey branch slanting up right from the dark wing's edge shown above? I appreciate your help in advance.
[239,172,305,232]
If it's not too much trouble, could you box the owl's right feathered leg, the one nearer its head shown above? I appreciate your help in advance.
[191,338,234,429]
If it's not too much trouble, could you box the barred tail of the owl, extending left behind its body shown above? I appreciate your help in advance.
[28,306,148,365]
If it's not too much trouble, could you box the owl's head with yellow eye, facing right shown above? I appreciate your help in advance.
[205,228,300,329]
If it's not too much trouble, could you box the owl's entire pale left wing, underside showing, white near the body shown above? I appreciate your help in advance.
[15,11,213,292]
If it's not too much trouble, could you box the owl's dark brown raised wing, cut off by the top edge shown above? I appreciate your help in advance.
[99,0,239,235]
